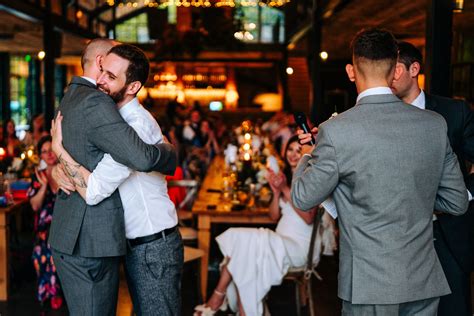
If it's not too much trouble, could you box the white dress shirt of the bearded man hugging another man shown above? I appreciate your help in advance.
[86,98,178,239]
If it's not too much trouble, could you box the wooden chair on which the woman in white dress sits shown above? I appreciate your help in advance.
[284,208,324,316]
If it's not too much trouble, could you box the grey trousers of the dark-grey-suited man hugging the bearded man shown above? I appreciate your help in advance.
[52,249,120,316]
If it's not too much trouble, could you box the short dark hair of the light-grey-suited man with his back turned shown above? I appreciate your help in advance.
[351,28,398,63]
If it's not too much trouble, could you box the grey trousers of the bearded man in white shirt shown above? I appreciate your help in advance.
[125,230,184,316]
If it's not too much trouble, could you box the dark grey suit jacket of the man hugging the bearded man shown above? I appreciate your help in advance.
[49,77,177,257]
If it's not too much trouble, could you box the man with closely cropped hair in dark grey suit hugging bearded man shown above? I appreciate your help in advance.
[49,39,176,315]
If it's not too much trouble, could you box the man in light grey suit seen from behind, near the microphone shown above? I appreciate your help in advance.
[291,29,468,316]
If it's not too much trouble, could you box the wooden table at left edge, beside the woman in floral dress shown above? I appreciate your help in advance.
[0,200,28,301]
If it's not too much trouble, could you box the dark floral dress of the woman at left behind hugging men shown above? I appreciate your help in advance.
[28,176,62,305]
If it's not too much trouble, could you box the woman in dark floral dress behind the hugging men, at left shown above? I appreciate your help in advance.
[28,136,62,309]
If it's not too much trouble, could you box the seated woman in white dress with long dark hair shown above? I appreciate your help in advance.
[194,136,334,316]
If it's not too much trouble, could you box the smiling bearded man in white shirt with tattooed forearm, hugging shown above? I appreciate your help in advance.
[53,45,183,315]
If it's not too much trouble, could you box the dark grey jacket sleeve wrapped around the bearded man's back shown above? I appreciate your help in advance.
[84,94,177,175]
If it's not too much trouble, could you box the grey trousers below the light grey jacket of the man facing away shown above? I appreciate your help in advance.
[342,297,439,316]
